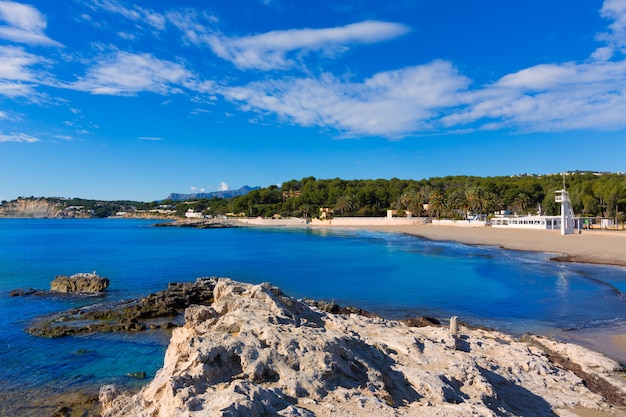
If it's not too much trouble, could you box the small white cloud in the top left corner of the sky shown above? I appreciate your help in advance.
[0,1,61,46]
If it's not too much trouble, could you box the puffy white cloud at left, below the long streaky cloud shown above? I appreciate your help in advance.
[67,52,192,95]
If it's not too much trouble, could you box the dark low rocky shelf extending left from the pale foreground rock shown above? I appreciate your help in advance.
[26,278,217,337]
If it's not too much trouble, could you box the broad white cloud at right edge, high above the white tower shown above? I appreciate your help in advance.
[442,54,626,131]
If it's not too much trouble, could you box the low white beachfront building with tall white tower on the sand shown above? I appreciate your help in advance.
[491,189,576,235]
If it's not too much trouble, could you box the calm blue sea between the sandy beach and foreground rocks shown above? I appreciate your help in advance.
[0,219,626,415]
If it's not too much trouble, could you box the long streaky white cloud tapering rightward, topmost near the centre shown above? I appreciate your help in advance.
[180,17,409,70]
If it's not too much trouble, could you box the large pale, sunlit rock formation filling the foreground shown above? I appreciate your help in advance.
[101,279,626,417]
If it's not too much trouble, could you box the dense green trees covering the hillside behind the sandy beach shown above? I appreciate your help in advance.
[149,172,626,218]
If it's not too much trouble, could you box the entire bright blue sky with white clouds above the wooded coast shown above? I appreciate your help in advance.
[0,0,626,201]
